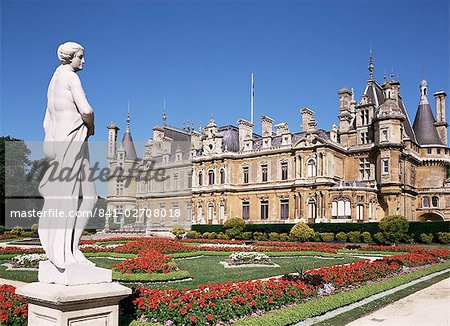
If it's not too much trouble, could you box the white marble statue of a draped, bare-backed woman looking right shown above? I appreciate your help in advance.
[39,42,106,284]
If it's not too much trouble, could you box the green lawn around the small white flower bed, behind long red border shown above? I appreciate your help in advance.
[142,256,359,289]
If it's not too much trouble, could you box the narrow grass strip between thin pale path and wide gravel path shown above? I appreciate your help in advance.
[314,272,450,326]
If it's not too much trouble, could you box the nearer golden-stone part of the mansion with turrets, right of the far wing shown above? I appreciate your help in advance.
[108,66,450,229]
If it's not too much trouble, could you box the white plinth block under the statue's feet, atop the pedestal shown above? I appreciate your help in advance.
[38,260,112,285]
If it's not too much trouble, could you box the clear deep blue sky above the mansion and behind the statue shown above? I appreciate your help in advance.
[0,0,449,145]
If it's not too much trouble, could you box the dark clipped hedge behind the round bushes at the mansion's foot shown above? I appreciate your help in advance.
[192,221,450,241]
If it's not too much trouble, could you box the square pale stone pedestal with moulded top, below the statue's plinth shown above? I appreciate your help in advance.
[16,282,131,326]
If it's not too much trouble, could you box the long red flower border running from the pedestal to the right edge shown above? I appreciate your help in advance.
[133,250,450,325]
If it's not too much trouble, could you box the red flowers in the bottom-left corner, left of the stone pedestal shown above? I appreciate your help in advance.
[0,284,28,326]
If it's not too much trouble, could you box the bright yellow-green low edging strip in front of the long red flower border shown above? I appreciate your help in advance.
[235,262,450,326]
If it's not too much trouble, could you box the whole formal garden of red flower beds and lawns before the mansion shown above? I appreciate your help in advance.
[0,215,450,325]
